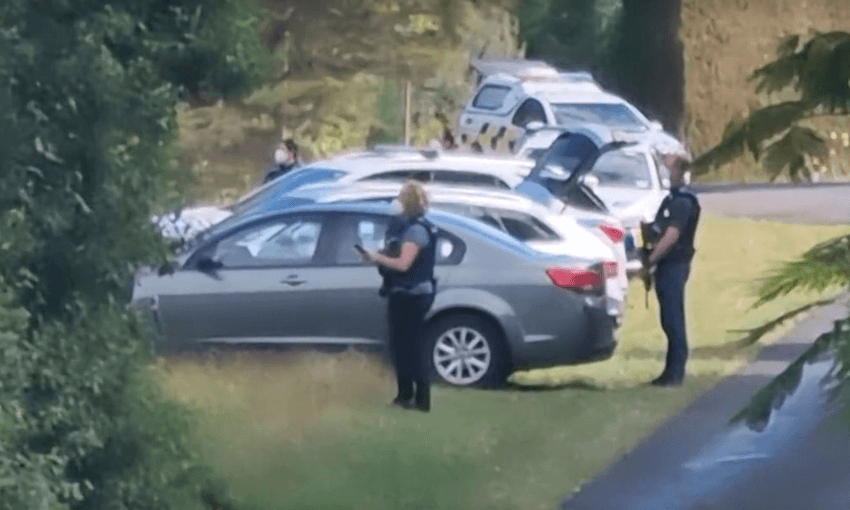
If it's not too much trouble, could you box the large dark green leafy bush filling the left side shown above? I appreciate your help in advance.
[0,0,263,510]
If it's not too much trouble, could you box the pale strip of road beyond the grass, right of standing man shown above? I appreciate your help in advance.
[693,184,850,225]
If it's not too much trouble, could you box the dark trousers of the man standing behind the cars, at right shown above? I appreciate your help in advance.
[655,260,691,380]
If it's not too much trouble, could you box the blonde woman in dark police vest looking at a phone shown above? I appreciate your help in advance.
[363,181,437,412]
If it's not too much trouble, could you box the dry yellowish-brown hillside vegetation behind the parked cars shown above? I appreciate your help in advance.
[179,0,519,203]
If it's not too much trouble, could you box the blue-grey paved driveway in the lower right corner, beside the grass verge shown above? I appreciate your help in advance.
[561,295,850,510]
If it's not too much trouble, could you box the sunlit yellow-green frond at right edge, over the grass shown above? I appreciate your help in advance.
[753,236,850,307]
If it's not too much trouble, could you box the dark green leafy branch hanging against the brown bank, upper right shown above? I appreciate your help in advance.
[694,32,850,182]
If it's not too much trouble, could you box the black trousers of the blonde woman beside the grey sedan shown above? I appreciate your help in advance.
[388,292,434,403]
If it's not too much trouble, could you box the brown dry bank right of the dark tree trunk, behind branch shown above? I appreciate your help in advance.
[681,0,850,181]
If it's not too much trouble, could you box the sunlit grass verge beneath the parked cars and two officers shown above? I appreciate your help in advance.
[158,215,845,510]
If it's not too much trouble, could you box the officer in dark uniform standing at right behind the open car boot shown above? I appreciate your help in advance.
[644,155,700,386]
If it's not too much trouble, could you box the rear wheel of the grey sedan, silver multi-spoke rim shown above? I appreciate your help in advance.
[425,313,510,388]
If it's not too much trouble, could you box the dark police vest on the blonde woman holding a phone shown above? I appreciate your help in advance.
[378,216,437,292]
